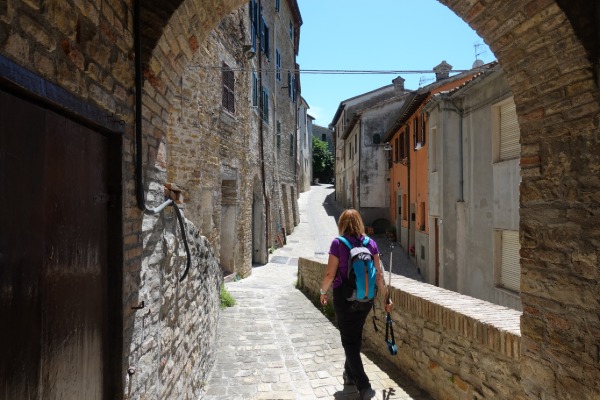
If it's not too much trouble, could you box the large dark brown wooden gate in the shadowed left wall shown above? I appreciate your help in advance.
[0,90,121,400]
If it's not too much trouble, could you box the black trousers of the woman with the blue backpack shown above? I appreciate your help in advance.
[333,288,373,390]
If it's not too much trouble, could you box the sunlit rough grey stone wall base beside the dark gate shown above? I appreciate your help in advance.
[124,203,223,400]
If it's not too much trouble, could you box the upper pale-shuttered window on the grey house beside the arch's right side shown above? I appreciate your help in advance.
[492,98,521,162]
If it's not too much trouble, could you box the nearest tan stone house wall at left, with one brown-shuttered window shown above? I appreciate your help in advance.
[167,8,255,276]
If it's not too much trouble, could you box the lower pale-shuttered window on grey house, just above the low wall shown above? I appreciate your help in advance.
[494,230,521,292]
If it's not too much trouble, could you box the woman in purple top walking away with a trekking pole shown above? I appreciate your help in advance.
[320,209,392,400]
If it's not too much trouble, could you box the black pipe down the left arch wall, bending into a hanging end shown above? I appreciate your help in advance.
[133,0,192,282]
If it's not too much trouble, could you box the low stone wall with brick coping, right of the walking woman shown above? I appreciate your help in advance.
[298,258,525,400]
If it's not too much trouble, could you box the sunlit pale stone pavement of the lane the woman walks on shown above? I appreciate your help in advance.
[202,185,430,400]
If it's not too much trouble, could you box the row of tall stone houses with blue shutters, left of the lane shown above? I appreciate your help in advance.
[168,1,301,277]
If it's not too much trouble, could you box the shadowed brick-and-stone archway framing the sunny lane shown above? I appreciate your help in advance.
[143,0,600,398]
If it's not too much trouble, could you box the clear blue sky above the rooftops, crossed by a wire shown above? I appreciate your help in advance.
[297,0,495,126]
